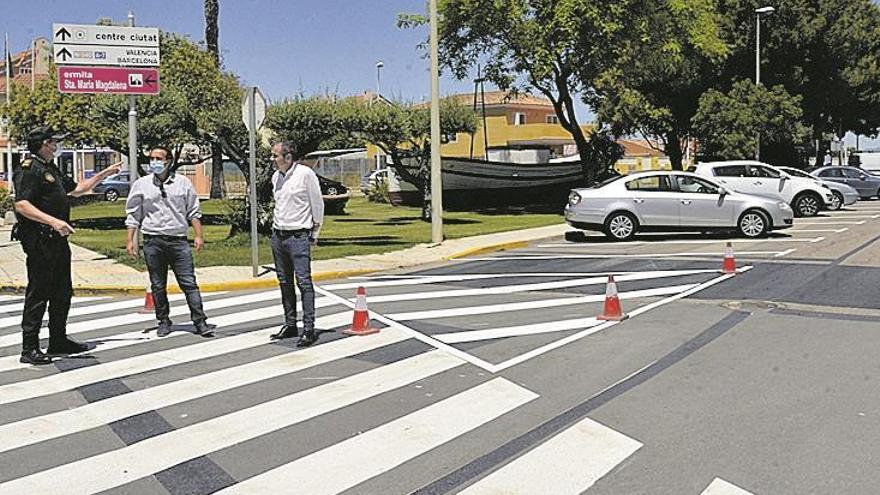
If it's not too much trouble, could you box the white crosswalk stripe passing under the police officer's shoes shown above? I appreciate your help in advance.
[0,298,292,372]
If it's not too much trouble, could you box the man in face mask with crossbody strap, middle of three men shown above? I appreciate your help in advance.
[125,146,213,337]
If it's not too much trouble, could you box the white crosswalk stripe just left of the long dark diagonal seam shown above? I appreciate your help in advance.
[218,378,547,495]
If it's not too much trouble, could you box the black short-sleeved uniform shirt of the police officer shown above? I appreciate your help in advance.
[12,156,76,229]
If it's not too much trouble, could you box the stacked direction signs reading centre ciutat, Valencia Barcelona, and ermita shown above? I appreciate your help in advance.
[52,24,160,95]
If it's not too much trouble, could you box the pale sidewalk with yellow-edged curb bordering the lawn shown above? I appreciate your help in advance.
[0,224,569,295]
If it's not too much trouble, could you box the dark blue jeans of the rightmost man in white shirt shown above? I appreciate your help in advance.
[272,230,315,332]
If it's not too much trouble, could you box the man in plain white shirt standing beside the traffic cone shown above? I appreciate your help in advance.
[271,143,324,347]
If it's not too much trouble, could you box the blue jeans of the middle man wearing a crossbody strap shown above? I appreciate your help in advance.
[144,235,207,324]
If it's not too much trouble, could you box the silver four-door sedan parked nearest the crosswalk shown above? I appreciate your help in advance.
[565,171,794,241]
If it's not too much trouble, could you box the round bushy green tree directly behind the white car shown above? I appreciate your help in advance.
[693,80,810,161]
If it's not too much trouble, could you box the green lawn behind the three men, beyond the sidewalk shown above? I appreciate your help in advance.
[71,197,562,270]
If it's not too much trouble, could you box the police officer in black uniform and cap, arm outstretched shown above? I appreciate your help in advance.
[13,127,121,364]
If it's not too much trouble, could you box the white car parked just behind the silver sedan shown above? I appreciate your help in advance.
[689,160,834,217]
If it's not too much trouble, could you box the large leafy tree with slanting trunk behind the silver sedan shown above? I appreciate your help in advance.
[399,0,723,182]
